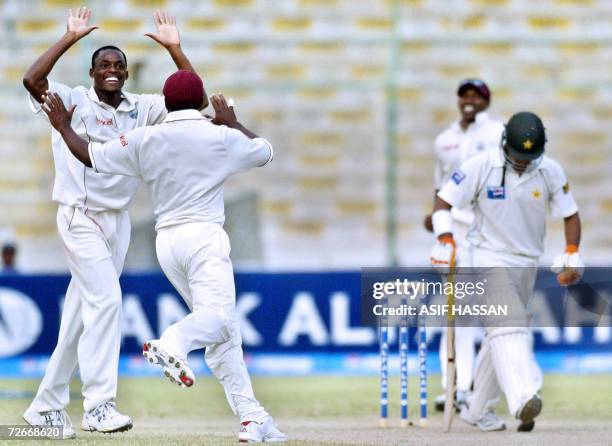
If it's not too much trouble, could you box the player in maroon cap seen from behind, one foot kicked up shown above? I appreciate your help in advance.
[44,70,285,442]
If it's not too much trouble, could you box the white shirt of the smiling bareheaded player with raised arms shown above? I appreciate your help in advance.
[30,80,167,211]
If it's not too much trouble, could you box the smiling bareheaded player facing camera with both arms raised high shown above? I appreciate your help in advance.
[23,8,193,438]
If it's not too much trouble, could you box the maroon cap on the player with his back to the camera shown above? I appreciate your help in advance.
[163,70,204,110]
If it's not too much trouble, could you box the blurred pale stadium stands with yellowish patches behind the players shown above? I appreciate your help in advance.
[0,0,612,271]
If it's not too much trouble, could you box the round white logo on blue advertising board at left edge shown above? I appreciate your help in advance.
[0,288,43,357]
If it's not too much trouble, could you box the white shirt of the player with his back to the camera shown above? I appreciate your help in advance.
[89,110,273,230]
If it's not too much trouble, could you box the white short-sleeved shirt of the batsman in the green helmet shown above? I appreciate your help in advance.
[438,150,578,259]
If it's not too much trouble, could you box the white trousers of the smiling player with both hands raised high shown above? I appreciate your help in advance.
[31,205,130,412]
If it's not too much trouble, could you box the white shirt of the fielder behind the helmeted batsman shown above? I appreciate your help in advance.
[434,112,504,225]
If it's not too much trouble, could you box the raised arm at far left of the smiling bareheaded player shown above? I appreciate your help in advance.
[23,7,98,103]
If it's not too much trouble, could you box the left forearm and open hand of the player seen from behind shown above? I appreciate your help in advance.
[41,92,92,167]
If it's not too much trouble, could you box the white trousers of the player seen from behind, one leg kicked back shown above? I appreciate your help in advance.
[156,223,269,422]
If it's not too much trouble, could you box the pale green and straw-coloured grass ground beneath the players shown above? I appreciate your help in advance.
[0,375,612,446]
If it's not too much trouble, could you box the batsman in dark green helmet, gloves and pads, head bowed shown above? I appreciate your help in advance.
[431,112,584,431]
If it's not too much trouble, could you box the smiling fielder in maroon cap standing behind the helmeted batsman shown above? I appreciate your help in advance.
[425,79,504,411]
